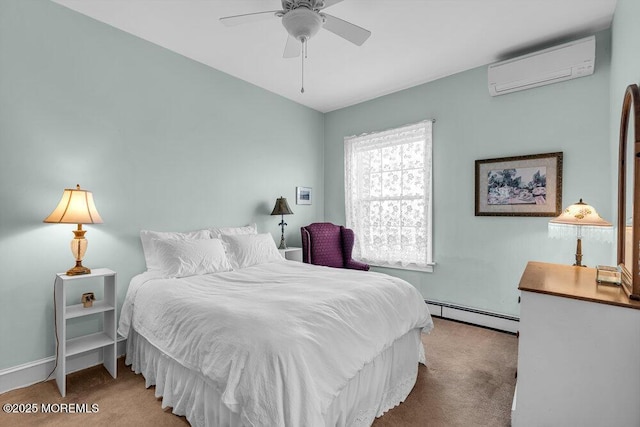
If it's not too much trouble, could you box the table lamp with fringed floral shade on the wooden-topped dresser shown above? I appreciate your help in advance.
[549,199,613,267]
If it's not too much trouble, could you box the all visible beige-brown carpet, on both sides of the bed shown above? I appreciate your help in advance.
[0,319,517,427]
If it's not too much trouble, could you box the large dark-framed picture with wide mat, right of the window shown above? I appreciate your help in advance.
[476,152,562,216]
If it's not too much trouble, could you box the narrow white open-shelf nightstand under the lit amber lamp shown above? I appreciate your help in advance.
[54,268,117,397]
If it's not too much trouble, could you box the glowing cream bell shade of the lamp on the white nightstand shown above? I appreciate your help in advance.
[44,185,102,224]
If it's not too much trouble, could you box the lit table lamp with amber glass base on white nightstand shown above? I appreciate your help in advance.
[44,185,102,276]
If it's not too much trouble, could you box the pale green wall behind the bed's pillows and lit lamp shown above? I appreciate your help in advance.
[0,0,324,369]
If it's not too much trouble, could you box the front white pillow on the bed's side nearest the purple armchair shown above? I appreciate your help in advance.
[222,233,282,269]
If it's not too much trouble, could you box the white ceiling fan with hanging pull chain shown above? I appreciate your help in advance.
[220,0,371,93]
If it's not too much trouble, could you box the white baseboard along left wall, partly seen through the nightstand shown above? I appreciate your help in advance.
[0,338,127,394]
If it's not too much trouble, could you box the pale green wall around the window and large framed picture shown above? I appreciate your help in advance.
[325,31,614,316]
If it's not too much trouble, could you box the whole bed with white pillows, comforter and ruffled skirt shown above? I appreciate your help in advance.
[118,229,433,426]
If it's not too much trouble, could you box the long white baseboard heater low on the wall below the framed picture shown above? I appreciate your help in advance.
[424,300,520,334]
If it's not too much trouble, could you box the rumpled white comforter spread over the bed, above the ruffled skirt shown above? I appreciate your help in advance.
[118,261,433,426]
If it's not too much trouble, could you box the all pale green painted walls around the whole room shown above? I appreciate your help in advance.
[0,0,640,369]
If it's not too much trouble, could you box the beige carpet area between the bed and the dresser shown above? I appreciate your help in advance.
[373,318,518,427]
